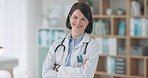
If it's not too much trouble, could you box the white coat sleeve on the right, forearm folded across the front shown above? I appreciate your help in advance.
[57,41,99,78]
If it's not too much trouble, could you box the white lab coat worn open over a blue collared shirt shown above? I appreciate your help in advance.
[42,33,99,78]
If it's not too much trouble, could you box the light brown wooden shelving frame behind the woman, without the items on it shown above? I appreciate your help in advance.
[78,0,148,78]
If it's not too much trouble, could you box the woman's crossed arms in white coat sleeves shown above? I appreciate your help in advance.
[42,40,99,78]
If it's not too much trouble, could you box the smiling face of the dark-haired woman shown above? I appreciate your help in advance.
[70,9,89,33]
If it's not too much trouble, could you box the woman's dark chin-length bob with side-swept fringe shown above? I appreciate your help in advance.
[66,2,93,34]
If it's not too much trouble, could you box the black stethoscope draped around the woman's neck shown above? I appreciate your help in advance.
[54,37,89,66]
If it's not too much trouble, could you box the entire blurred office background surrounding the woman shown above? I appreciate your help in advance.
[0,0,148,78]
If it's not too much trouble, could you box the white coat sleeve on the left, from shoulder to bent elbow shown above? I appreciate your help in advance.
[42,43,57,78]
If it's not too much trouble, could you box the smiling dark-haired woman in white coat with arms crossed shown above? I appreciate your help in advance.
[42,2,99,78]
